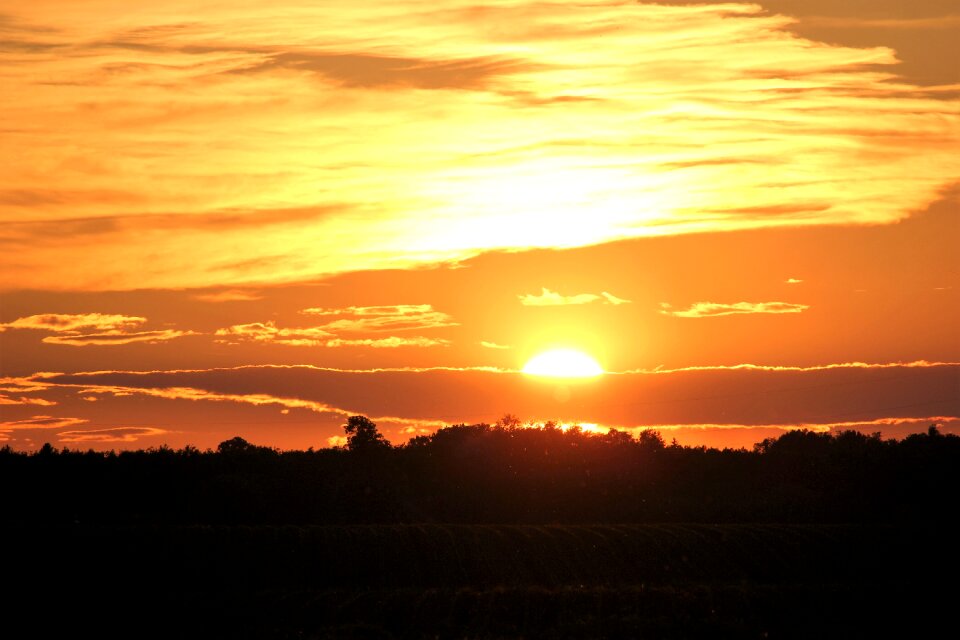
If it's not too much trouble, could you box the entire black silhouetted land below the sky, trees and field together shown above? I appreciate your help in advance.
[0,424,960,640]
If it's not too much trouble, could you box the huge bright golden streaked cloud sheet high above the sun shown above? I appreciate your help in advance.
[0,0,960,290]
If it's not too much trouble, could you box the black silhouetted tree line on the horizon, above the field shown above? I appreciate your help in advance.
[0,416,960,524]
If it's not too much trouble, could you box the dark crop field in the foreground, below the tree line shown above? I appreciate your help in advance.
[2,524,960,638]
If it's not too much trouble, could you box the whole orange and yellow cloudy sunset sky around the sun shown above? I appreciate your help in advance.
[0,0,960,450]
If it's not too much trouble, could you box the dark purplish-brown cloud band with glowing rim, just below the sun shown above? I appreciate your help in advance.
[18,362,960,438]
